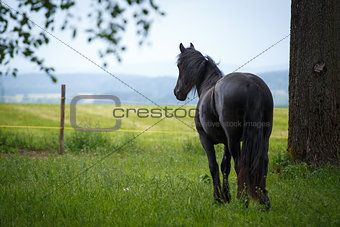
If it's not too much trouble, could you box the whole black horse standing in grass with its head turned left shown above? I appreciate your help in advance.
[174,43,273,209]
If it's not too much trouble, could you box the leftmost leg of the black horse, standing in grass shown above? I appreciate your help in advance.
[200,134,222,202]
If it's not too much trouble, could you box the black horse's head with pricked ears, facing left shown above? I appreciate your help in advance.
[174,43,204,101]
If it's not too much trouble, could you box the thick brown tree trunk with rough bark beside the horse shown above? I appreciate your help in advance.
[288,0,340,165]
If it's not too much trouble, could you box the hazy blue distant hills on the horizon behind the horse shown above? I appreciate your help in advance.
[0,71,288,106]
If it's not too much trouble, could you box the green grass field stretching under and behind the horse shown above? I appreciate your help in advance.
[0,104,340,226]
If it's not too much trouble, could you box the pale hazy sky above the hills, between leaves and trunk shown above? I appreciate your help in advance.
[8,0,290,76]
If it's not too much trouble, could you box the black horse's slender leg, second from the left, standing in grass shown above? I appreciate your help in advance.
[221,145,231,203]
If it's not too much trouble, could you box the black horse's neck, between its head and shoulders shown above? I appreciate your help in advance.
[196,66,222,97]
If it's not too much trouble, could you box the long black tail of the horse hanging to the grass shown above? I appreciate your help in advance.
[238,88,268,199]
